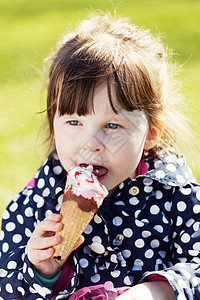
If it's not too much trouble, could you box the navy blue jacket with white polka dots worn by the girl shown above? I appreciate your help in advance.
[0,152,200,300]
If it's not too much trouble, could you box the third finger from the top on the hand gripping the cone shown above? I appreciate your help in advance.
[28,235,61,251]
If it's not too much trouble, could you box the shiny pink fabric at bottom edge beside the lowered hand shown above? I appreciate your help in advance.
[69,284,130,300]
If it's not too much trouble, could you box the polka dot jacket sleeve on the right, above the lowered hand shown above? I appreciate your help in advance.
[141,184,200,300]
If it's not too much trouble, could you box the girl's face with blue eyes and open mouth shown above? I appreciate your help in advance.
[54,84,148,191]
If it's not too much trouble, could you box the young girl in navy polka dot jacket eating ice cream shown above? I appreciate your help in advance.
[0,16,200,300]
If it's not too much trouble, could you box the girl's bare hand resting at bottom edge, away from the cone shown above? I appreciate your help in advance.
[116,281,176,300]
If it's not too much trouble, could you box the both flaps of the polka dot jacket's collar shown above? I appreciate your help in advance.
[35,150,196,199]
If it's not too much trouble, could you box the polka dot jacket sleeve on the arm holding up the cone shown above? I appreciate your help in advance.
[0,188,52,300]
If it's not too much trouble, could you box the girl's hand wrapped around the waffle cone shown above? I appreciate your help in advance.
[27,214,84,278]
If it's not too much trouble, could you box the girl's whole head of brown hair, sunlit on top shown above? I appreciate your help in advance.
[44,15,190,155]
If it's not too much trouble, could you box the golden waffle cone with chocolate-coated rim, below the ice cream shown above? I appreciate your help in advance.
[53,191,98,260]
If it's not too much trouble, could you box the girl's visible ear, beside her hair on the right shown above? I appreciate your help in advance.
[144,120,165,150]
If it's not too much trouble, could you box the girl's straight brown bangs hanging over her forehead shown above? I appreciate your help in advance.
[58,49,147,116]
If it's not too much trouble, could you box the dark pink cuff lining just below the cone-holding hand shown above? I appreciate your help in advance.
[53,260,73,295]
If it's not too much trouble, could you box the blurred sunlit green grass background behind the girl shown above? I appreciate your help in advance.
[0,0,200,215]
